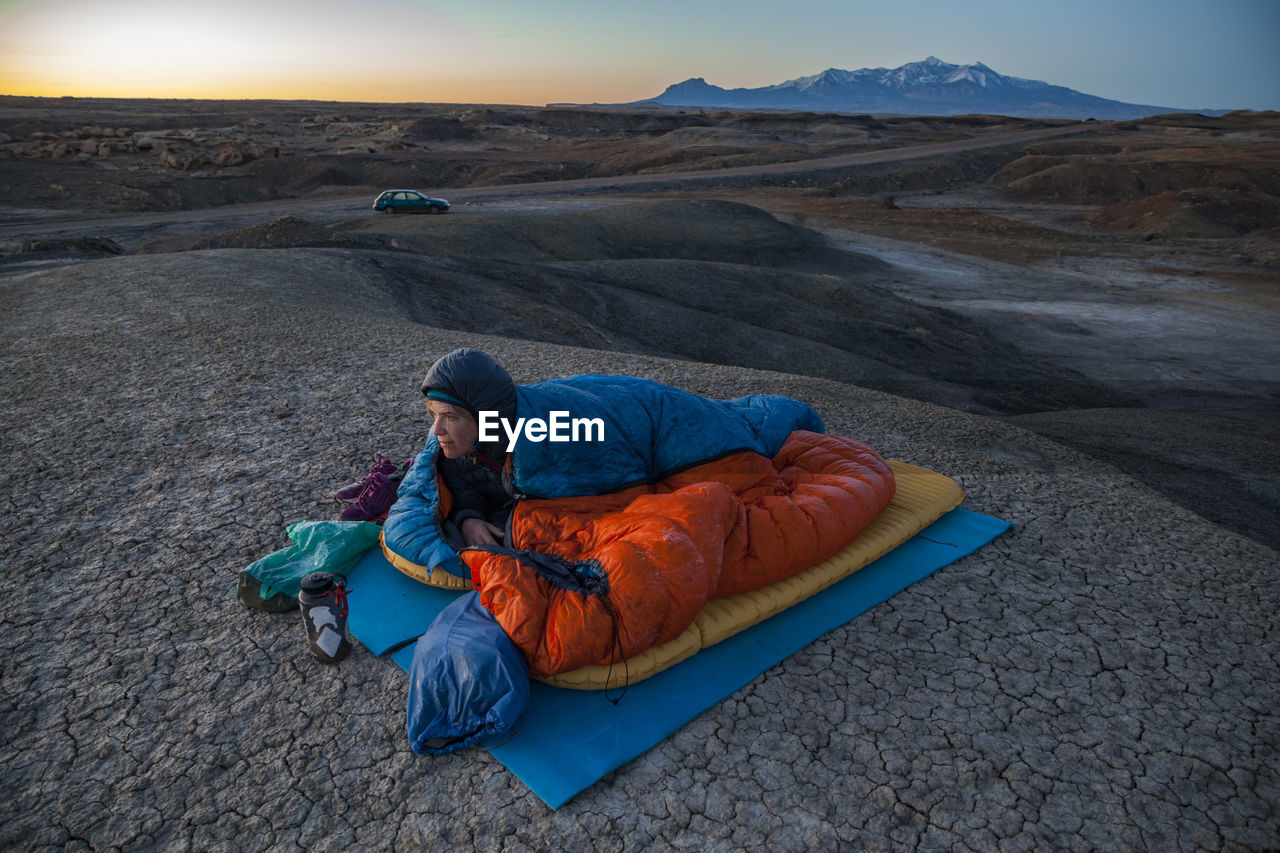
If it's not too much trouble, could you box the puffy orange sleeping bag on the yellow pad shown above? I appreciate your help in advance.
[460,430,893,676]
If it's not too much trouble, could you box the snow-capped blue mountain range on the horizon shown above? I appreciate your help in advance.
[639,56,1179,119]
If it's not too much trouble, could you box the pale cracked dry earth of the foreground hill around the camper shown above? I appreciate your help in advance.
[0,244,1280,852]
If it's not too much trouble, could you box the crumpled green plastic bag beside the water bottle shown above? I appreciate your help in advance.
[244,521,381,599]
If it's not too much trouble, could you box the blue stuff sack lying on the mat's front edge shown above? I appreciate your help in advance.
[406,592,529,756]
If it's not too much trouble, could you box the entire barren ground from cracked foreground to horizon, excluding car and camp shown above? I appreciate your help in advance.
[0,97,1280,849]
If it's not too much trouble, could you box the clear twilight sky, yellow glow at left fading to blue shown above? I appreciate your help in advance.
[0,0,1280,109]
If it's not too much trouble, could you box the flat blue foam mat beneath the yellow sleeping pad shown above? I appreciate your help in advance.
[347,508,1012,808]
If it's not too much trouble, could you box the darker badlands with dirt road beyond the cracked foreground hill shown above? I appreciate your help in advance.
[0,97,1280,546]
